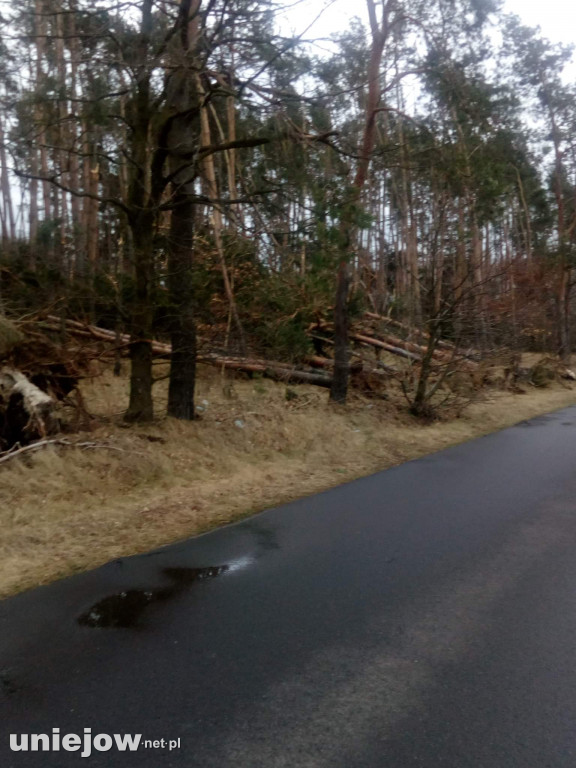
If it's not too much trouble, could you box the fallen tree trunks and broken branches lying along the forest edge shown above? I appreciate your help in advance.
[0,312,576,464]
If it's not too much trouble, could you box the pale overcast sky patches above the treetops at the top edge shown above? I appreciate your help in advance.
[286,0,576,49]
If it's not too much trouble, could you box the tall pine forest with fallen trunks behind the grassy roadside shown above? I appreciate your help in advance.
[0,0,576,440]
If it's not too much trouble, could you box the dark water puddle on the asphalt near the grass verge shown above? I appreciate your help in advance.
[77,565,229,629]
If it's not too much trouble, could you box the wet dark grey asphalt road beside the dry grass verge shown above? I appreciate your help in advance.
[0,408,576,768]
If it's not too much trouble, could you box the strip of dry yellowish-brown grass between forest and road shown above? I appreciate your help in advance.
[0,356,576,596]
